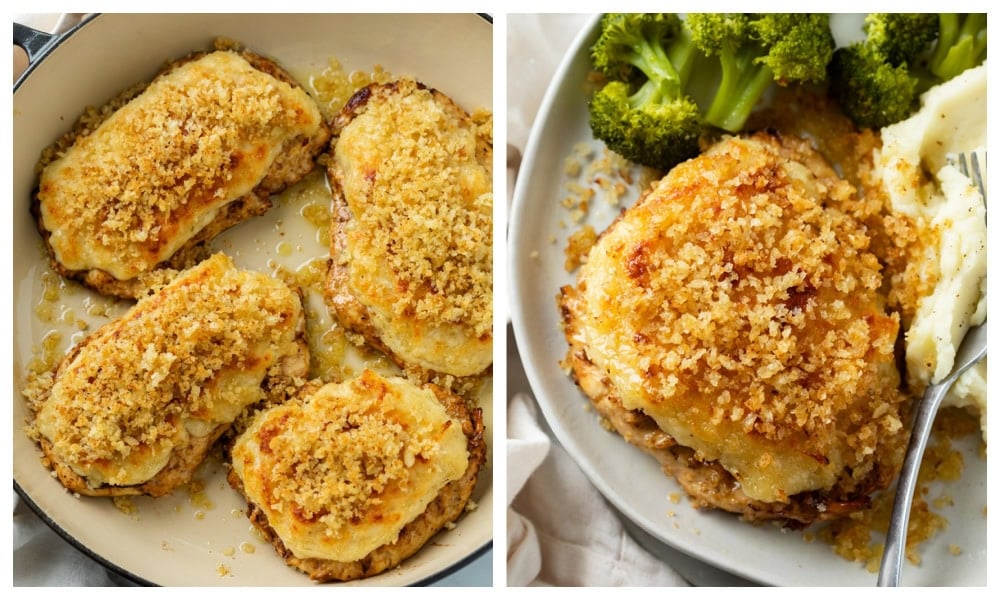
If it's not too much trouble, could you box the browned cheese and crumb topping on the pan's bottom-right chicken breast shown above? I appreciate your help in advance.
[232,370,468,561]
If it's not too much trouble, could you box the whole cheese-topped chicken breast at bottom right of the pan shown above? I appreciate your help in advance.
[229,370,486,581]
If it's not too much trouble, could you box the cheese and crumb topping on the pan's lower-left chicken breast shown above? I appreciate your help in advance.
[36,254,302,487]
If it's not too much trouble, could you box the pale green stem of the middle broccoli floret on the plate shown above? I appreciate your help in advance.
[705,50,774,132]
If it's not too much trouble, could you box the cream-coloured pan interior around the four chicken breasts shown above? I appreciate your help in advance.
[12,14,493,586]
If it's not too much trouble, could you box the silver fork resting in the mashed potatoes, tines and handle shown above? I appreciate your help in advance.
[878,153,986,587]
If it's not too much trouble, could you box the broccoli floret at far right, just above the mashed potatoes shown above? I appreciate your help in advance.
[829,13,986,129]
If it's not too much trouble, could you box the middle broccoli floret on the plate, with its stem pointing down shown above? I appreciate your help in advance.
[686,13,836,132]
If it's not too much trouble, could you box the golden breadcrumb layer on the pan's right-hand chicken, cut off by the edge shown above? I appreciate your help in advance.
[338,79,493,337]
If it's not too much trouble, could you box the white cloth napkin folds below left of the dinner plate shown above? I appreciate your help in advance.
[507,394,687,587]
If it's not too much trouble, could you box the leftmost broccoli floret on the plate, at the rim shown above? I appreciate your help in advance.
[589,13,701,170]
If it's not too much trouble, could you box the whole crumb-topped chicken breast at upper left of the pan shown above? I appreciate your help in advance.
[32,43,330,298]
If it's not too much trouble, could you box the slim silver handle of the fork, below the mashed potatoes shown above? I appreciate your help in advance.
[878,377,954,587]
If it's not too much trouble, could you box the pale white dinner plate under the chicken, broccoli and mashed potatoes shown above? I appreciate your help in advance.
[509,14,986,586]
